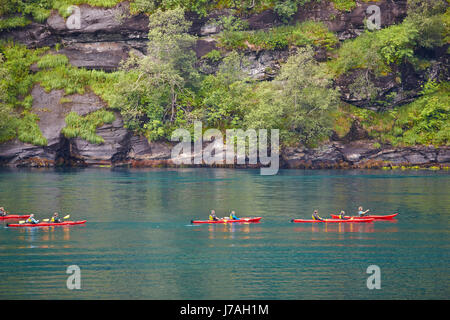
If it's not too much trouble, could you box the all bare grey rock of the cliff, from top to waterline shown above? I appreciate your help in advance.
[0,0,450,168]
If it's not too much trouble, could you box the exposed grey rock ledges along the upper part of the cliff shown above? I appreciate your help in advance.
[0,0,412,79]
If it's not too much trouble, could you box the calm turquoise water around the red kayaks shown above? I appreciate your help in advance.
[0,169,450,299]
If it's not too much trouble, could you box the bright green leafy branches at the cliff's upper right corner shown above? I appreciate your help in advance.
[329,0,449,76]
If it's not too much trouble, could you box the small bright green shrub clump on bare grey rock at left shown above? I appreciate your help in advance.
[62,110,115,144]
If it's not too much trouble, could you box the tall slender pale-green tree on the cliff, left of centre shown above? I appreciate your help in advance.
[117,8,198,139]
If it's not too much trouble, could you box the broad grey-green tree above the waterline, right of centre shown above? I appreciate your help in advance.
[246,47,339,146]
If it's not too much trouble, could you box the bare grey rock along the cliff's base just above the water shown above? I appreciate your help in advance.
[0,85,450,169]
